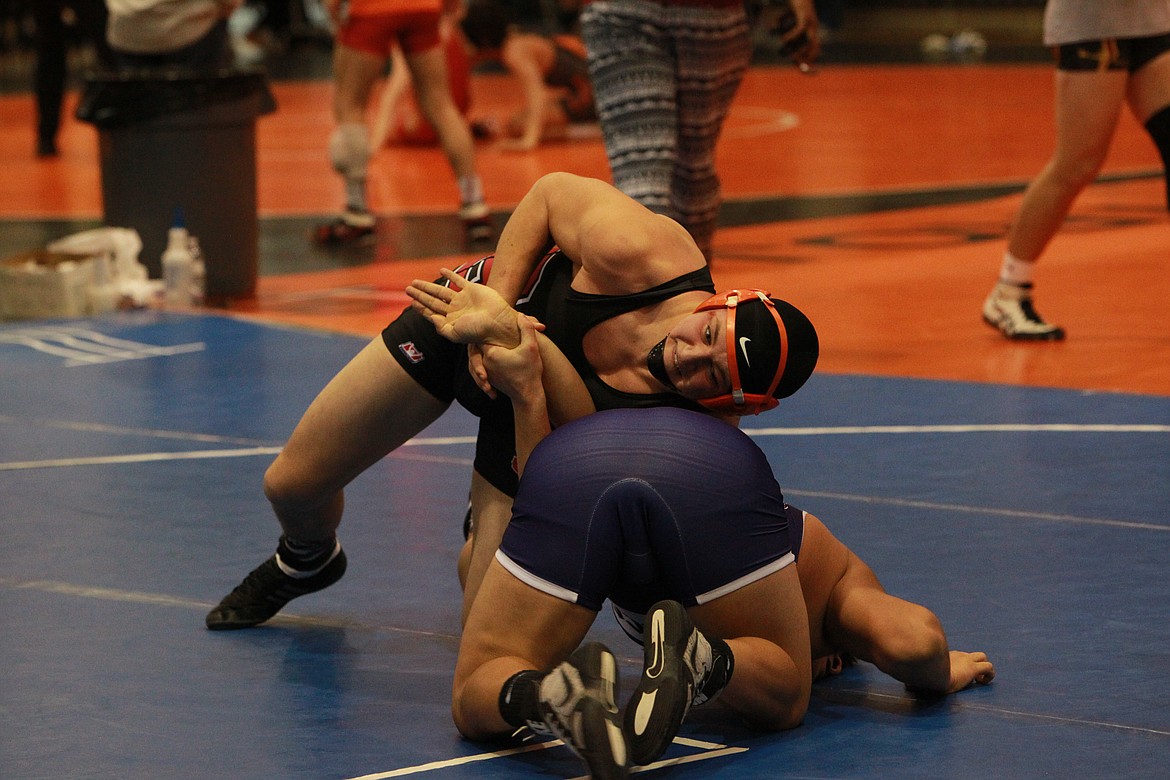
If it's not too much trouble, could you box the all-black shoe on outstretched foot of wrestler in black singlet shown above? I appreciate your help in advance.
[205,545,345,631]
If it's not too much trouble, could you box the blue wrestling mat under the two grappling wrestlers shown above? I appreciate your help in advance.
[0,312,1170,780]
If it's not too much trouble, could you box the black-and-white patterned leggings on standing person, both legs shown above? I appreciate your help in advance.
[580,0,751,258]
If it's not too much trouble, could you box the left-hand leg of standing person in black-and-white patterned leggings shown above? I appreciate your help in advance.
[581,0,680,219]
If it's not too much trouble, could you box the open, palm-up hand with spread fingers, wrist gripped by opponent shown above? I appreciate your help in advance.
[406,268,531,348]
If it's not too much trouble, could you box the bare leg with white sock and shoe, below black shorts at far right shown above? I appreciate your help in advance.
[983,63,1128,340]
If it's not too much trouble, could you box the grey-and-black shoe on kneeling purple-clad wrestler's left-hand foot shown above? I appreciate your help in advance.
[534,642,629,780]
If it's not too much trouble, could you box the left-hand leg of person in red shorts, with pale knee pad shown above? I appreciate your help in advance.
[314,32,387,244]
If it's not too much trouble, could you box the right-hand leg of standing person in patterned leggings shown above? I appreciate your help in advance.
[667,6,751,262]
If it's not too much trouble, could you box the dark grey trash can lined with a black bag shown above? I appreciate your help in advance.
[77,69,276,304]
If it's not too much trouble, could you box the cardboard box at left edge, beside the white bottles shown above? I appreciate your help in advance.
[0,249,94,319]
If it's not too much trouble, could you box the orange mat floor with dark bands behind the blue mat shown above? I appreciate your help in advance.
[0,59,1170,394]
